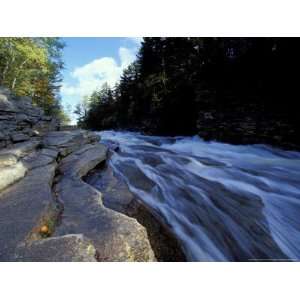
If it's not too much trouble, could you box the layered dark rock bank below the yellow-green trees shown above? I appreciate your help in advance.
[0,87,59,149]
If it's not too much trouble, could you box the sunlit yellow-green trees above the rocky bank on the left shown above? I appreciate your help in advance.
[0,37,69,122]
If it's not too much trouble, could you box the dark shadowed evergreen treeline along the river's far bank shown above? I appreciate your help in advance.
[77,38,300,145]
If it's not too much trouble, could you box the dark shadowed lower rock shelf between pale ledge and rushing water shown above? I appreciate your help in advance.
[84,162,186,262]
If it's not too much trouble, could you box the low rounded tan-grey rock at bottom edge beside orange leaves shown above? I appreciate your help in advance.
[15,234,96,262]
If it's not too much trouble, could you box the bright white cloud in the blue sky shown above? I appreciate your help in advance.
[61,47,136,97]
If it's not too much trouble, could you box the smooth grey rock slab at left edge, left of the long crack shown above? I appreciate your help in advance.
[0,163,56,261]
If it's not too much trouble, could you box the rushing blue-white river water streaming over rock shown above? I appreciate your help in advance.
[100,131,300,261]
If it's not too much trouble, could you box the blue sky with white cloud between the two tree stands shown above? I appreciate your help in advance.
[61,37,142,124]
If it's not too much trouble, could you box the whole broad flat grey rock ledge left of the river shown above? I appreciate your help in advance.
[0,130,156,261]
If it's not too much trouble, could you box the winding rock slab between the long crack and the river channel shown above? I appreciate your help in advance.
[55,144,155,261]
